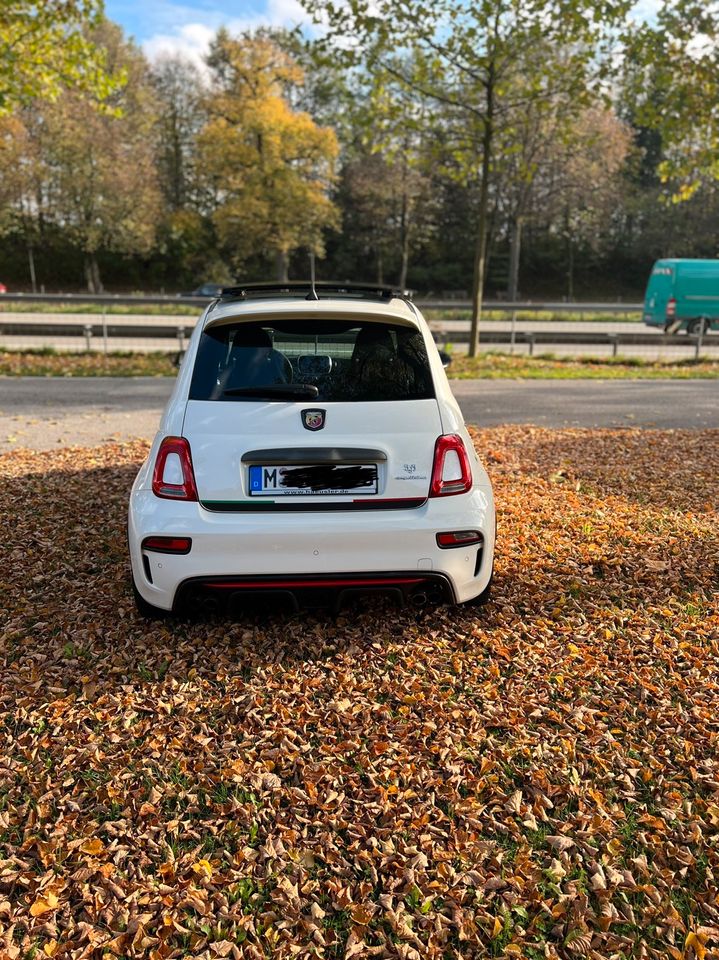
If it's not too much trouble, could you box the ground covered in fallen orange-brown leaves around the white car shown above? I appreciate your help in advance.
[0,428,719,960]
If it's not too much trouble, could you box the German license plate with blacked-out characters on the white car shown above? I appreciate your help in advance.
[250,463,377,497]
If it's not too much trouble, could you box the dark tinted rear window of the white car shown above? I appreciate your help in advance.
[190,320,434,401]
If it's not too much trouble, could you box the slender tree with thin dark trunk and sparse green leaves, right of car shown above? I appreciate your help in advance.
[306,0,630,355]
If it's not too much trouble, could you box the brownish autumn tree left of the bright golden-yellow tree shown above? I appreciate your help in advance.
[43,21,160,293]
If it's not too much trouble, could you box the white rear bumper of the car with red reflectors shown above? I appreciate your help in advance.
[128,487,495,610]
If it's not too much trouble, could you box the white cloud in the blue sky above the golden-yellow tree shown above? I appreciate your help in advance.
[142,0,309,69]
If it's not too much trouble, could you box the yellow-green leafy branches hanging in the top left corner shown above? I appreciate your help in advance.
[0,0,122,115]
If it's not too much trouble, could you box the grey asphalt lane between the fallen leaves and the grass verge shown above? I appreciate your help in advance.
[0,377,719,452]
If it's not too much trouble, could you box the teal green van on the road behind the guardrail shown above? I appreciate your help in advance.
[643,260,719,334]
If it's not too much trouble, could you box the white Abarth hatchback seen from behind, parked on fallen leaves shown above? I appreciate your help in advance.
[128,283,495,616]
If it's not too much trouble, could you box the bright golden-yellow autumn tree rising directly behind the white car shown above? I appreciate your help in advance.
[198,30,339,279]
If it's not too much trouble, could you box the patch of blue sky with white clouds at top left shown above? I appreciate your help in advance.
[105,0,308,59]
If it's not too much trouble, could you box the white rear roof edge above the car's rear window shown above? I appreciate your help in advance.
[204,294,421,329]
